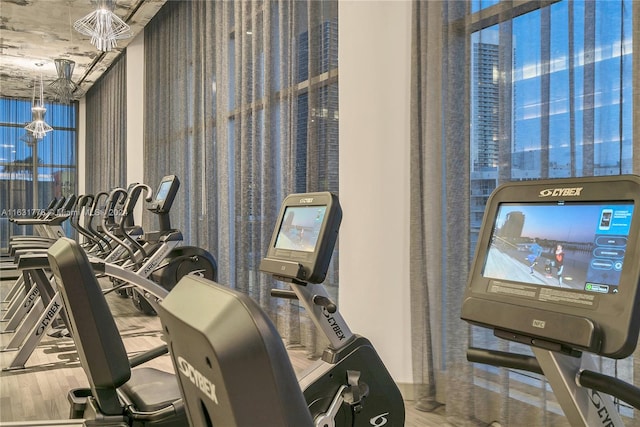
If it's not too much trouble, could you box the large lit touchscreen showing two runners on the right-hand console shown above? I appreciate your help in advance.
[483,202,634,294]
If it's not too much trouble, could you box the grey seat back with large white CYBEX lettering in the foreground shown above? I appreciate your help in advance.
[158,275,313,427]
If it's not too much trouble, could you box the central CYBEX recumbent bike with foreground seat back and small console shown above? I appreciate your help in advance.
[159,193,405,427]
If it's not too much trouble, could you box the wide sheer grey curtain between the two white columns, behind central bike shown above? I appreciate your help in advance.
[145,0,338,351]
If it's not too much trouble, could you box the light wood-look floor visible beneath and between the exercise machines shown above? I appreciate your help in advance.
[0,280,451,427]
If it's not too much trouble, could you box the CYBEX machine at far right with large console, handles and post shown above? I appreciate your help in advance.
[461,176,640,427]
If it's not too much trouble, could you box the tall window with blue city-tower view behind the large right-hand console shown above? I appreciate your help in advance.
[468,0,637,425]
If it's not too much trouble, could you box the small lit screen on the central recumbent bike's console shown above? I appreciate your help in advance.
[275,206,327,252]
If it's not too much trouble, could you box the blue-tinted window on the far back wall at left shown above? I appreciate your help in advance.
[0,98,77,250]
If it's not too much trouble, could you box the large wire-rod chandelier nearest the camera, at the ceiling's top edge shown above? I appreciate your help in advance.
[73,0,131,52]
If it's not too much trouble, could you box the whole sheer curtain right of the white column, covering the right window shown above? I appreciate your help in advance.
[410,0,640,426]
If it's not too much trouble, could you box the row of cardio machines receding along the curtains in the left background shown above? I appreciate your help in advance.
[0,175,217,370]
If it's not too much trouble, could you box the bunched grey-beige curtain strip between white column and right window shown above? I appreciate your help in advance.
[410,2,473,422]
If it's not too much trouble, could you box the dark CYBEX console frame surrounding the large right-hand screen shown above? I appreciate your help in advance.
[461,175,640,358]
